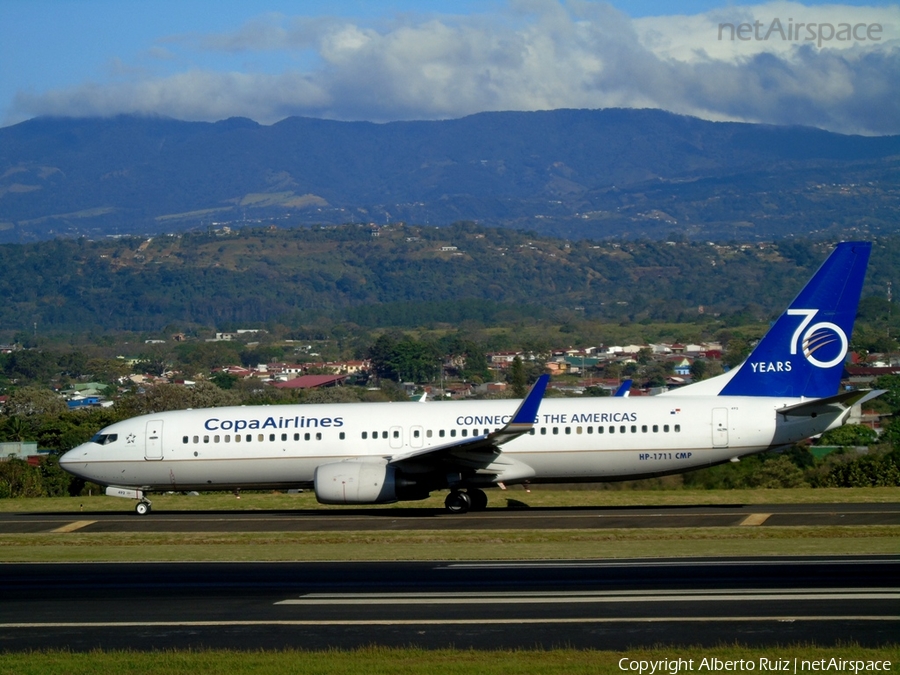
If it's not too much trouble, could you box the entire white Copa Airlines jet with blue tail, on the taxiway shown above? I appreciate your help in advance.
[60,242,879,514]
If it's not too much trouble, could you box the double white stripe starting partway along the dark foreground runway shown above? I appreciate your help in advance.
[274,588,900,605]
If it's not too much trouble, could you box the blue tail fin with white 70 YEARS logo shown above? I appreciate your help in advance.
[719,242,872,398]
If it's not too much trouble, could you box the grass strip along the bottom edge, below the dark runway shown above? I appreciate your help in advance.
[0,644,900,675]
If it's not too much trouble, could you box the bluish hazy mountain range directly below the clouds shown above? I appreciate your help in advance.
[0,109,900,243]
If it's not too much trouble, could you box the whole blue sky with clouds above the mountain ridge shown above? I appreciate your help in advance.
[0,0,900,134]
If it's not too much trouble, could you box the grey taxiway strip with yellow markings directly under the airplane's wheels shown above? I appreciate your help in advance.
[0,503,900,534]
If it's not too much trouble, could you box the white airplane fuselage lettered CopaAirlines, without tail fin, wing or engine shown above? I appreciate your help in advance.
[63,396,842,491]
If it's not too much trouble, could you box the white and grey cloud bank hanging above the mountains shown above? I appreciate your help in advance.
[15,0,900,134]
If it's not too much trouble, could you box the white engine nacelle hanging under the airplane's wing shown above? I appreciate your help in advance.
[313,460,397,504]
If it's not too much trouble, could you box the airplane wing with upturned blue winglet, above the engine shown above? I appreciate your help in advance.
[388,375,550,481]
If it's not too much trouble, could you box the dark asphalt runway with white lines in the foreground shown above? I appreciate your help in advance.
[0,556,900,651]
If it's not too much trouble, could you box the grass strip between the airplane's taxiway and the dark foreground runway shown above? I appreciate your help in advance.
[0,525,900,562]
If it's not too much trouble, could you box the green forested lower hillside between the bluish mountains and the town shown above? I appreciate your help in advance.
[0,223,900,341]
